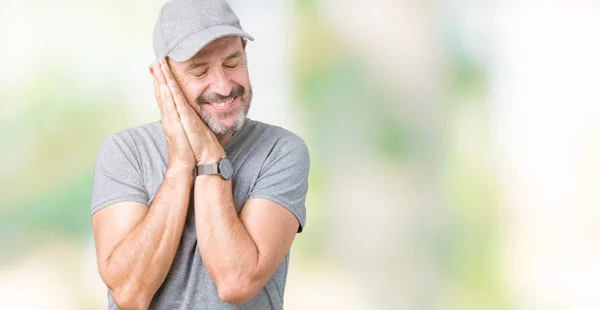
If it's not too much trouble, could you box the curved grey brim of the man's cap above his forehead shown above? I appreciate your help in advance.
[167,26,254,62]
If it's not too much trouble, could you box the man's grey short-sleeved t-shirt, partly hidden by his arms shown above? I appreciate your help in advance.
[92,119,309,309]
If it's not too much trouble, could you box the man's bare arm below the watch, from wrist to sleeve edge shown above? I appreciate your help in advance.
[194,175,299,304]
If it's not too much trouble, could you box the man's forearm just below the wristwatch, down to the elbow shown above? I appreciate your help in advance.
[194,175,260,303]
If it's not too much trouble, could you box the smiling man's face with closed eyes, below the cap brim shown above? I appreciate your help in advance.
[167,37,252,136]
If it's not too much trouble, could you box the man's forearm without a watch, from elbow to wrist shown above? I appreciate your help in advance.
[104,169,192,308]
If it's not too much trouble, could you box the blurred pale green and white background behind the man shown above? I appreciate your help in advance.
[0,0,600,310]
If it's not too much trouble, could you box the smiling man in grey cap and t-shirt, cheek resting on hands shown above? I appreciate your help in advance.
[92,0,309,309]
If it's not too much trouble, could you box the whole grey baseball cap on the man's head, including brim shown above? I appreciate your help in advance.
[152,0,254,62]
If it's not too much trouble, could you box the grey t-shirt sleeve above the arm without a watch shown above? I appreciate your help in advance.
[91,133,148,214]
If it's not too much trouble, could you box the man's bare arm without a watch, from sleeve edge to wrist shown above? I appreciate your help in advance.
[92,169,192,309]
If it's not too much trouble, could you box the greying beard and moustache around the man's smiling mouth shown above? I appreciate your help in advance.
[196,84,252,137]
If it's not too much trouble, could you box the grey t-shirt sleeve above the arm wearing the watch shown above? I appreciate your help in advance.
[249,135,310,232]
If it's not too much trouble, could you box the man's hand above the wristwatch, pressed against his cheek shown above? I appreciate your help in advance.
[155,58,225,164]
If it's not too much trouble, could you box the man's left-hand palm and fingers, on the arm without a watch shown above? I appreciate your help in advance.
[150,62,196,171]
